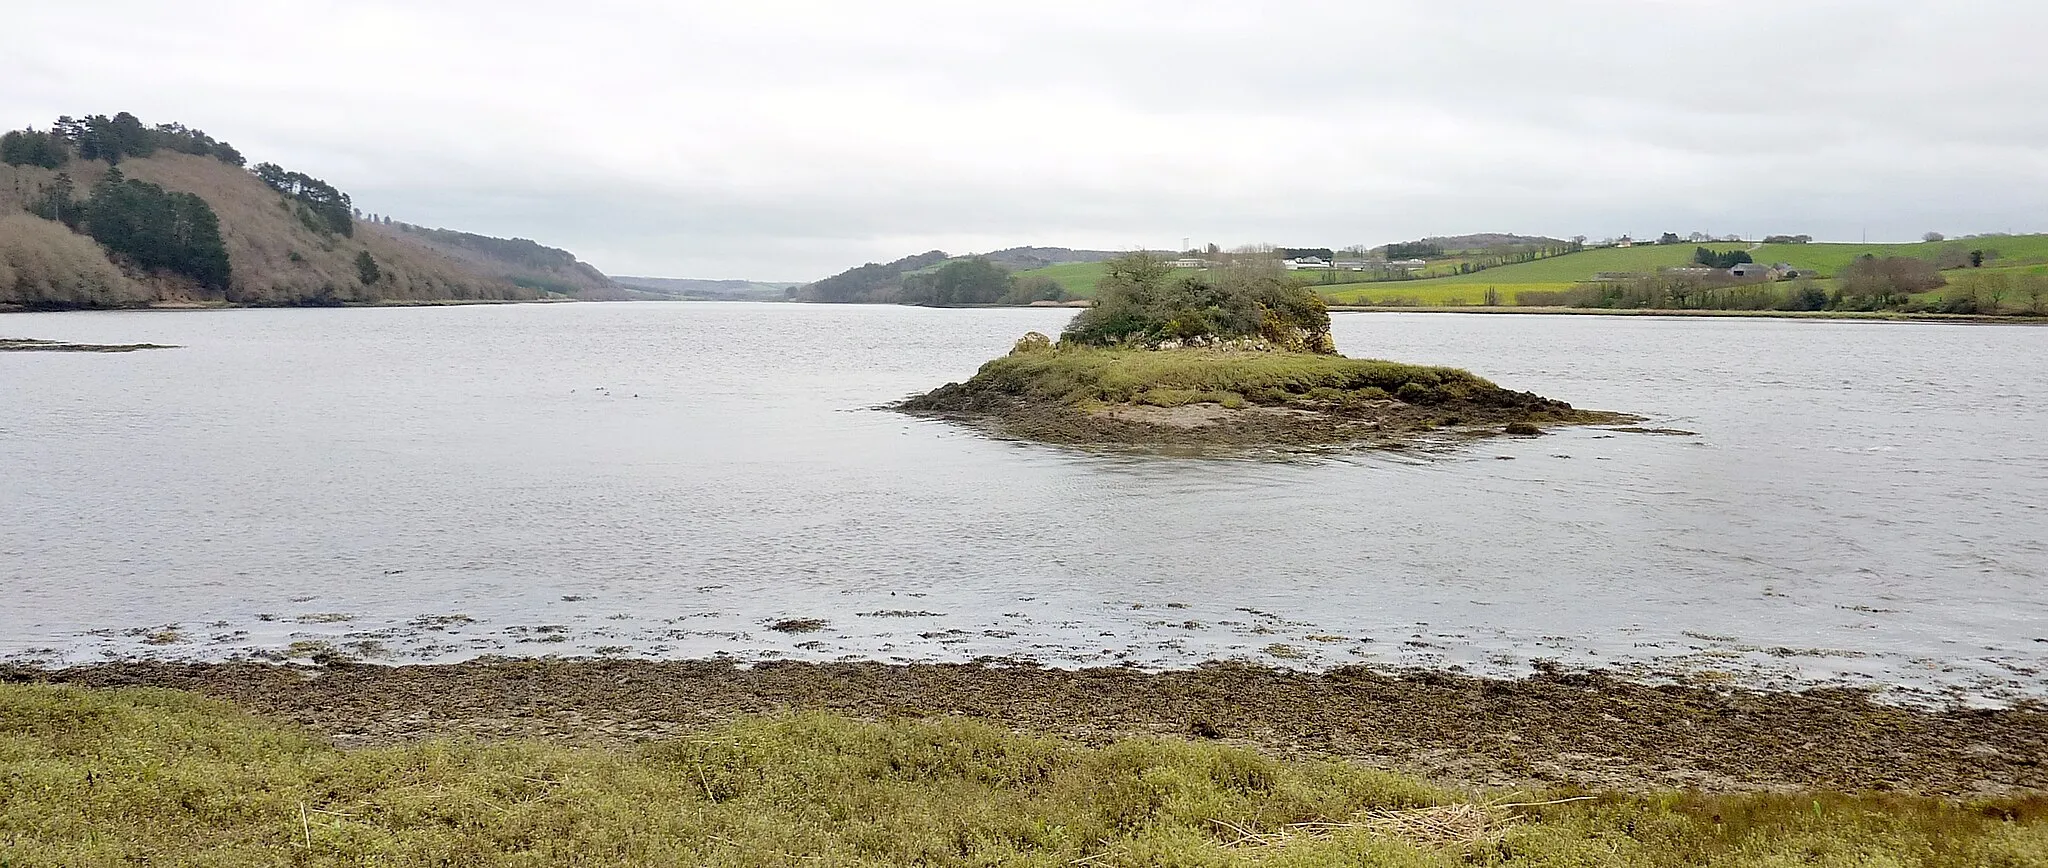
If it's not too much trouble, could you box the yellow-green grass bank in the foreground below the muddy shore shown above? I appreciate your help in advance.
[0,686,2048,866]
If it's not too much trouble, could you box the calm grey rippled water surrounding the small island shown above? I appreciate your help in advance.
[0,303,2048,698]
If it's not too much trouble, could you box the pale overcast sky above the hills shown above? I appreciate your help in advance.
[0,0,2048,280]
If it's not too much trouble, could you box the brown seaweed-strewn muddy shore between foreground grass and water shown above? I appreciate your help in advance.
[19,659,2048,796]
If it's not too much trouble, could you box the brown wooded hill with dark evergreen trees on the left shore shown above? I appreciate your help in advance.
[0,113,621,309]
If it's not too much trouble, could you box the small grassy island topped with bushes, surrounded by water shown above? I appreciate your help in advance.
[895,254,1638,448]
